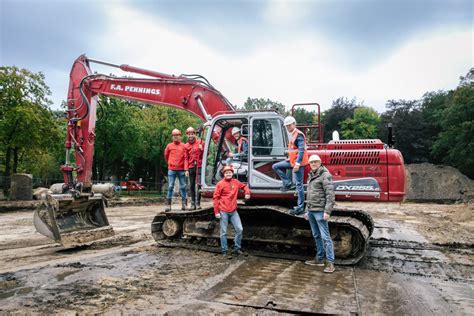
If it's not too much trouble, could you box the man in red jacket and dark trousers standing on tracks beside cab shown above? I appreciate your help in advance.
[185,127,204,210]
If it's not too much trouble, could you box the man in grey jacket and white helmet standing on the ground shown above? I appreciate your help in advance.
[304,155,335,273]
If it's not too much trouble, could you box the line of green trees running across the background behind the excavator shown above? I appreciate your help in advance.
[0,66,474,194]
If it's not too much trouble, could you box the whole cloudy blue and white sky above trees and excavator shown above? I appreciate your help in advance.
[0,0,474,112]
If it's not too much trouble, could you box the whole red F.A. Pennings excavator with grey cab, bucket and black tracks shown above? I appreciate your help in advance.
[34,55,405,264]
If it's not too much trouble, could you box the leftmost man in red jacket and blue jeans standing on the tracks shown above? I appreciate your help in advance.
[165,128,188,211]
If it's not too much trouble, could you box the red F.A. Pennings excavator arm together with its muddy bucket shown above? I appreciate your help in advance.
[33,55,235,247]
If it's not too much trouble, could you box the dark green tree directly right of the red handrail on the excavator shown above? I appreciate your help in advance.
[321,97,361,141]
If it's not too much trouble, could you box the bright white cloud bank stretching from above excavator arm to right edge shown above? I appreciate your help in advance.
[81,4,472,112]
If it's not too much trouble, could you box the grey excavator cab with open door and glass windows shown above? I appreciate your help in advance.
[201,111,288,197]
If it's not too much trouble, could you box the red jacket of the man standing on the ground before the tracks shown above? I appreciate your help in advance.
[212,179,250,215]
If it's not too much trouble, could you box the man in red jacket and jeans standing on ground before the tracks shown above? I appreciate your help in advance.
[212,166,250,259]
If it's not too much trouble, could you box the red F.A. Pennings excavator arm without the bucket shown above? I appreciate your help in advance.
[65,55,235,191]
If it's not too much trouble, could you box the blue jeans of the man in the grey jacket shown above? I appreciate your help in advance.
[308,211,334,263]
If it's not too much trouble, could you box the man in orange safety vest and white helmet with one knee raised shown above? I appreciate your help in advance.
[273,116,308,215]
